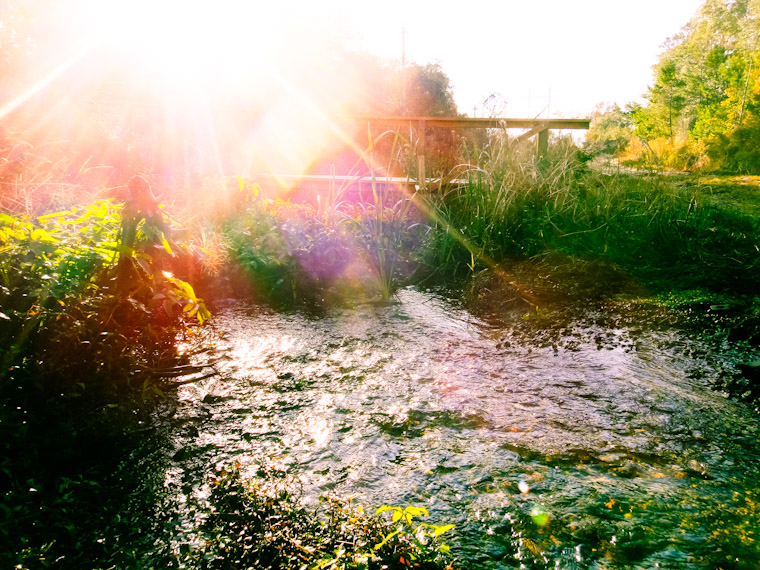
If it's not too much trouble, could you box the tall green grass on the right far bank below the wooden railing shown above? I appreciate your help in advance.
[426,133,760,289]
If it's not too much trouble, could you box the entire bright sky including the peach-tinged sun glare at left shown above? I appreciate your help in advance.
[0,0,704,172]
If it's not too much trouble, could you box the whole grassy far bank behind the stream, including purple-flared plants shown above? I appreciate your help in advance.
[208,133,760,318]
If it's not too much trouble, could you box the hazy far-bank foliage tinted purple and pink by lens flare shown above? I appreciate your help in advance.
[224,174,421,304]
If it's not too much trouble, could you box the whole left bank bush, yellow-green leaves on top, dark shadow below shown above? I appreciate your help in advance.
[0,197,209,565]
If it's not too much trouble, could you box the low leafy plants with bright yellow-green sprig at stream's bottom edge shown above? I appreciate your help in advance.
[180,467,453,570]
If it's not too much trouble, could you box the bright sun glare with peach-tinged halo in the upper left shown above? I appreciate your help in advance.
[0,0,372,179]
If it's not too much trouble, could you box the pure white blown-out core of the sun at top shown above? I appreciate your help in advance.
[73,0,287,97]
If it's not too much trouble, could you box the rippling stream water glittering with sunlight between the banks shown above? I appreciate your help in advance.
[131,289,760,569]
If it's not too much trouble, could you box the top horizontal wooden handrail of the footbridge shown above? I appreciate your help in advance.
[354,115,591,130]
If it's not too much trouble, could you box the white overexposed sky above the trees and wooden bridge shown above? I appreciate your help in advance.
[29,0,704,122]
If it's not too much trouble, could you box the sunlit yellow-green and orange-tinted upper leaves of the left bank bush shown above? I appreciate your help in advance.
[0,201,209,385]
